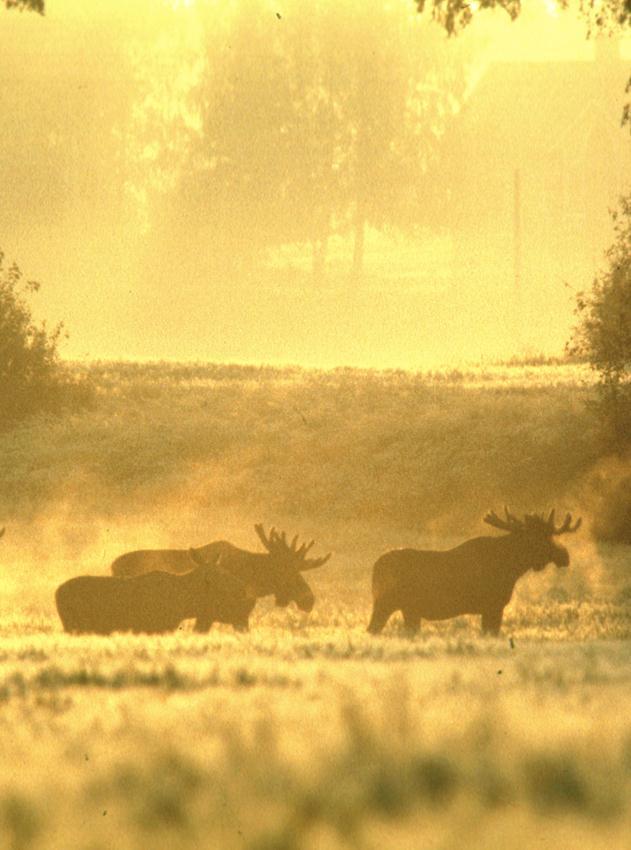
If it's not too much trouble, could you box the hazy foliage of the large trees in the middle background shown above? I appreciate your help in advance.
[135,0,465,282]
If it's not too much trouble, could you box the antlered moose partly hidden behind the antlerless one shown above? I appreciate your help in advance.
[111,523,331,631]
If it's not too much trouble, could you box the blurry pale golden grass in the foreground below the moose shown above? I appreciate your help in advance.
[0,619,631,850]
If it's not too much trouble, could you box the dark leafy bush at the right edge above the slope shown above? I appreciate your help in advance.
[569,195,631,452]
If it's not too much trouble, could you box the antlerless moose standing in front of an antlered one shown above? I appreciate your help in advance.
[55,553,256,635]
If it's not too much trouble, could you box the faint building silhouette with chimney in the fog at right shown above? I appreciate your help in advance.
[428,39,631,344]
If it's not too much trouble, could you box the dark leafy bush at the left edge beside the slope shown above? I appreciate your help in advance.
[0,251,88,428]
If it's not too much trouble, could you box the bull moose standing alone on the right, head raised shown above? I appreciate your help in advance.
[368,508,581,635]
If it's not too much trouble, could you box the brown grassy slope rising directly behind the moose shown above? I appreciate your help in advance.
[0,364,602,533]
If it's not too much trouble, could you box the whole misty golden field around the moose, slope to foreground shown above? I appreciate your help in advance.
[0,364,631,850]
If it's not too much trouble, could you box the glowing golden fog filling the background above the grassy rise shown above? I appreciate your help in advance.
[0,0,631,368]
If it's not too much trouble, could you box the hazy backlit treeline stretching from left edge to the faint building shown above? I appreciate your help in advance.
[0,0,475,286]
